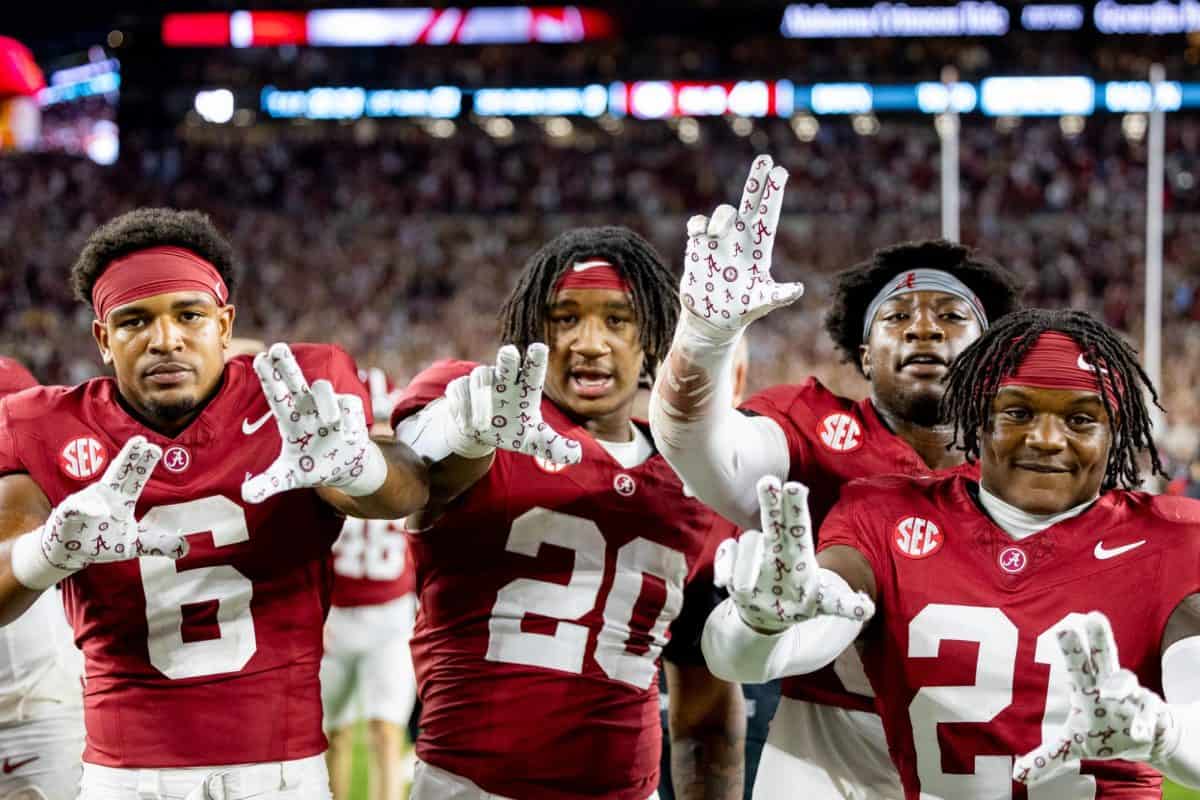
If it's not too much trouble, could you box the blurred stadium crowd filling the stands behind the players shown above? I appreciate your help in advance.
[0,116,1200,479]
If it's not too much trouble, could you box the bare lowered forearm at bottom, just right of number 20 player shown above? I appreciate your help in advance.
[662,660,746,800]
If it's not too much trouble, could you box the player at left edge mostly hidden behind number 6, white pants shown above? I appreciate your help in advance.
[0,356,83,800]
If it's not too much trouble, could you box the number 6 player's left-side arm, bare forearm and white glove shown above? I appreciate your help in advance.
[0,437,187,622]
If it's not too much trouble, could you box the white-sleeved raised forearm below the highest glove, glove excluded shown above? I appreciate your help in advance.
[650,311,788,528]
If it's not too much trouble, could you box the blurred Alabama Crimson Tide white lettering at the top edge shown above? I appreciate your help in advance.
[780,0,1008,38]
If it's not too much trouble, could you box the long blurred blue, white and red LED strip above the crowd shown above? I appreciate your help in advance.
[250,73,1200,122]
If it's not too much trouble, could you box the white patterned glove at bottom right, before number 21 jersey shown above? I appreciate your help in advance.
[1013,612,1172,784]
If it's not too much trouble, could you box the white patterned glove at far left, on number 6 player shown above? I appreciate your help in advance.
[12,437,187,590]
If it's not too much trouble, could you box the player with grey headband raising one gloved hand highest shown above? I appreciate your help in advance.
[650,156,1018,800]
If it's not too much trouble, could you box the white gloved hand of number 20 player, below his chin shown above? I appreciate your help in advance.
[445,342,583,464]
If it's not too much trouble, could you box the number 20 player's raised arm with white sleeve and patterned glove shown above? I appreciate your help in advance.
[396,342,583,513]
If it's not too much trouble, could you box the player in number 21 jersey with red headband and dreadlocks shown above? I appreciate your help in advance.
[706,309,1200,800]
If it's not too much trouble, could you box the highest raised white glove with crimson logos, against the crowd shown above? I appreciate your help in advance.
[679,156,804,330]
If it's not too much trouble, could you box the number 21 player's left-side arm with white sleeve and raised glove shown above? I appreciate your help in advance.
[701,475,875,684]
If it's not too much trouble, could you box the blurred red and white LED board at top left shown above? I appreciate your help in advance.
[162,6,616,47]
